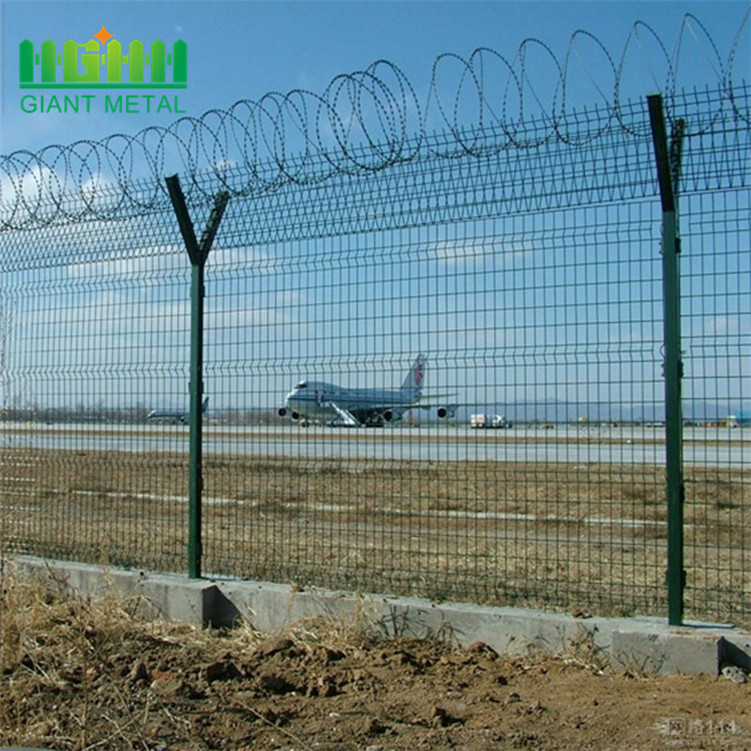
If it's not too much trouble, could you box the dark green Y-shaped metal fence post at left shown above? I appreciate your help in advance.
[166,175,229,579]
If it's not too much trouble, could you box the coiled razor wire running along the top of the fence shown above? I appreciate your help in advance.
[0,8,751,228]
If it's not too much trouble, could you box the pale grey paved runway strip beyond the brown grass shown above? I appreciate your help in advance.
[0,423,751,467]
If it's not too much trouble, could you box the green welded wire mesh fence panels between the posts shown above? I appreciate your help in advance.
[0,47,751,621]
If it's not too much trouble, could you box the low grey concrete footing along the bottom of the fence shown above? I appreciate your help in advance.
[8,557,751,675]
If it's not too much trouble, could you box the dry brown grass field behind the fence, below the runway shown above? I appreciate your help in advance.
[0,448,751,623]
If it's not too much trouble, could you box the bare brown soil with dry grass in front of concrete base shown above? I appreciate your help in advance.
[0,573,751,751]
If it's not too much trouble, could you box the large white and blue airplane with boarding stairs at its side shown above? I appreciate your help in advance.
[278,355,458,428]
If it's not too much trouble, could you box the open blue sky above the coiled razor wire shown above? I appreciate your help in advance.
[0,0,749,154]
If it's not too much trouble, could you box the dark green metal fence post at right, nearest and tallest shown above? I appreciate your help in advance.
[647,94,686,626]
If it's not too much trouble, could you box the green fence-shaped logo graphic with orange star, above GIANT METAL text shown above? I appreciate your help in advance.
[18,26,188,89]
